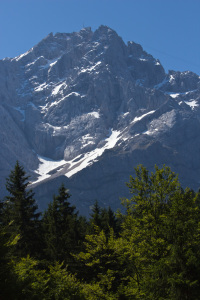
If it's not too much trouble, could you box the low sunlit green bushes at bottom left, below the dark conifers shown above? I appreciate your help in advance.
[15,257,85,300]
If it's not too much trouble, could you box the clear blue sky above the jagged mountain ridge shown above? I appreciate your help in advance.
[0,0,200,75]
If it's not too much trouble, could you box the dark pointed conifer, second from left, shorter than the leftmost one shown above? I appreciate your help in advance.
[43,184,78,264]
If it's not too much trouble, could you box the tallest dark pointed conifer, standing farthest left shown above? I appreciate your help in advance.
[3,162,40,256]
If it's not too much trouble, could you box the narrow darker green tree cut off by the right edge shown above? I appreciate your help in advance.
[163,189,200,299]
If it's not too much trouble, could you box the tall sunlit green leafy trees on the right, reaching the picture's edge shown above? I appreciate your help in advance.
[123,166,200,299]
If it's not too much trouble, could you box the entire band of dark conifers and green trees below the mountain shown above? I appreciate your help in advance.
[0,162,200,300]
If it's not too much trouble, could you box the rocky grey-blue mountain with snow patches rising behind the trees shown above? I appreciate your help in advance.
[0,26,200,215]
